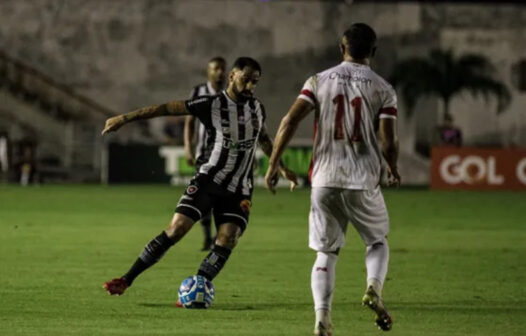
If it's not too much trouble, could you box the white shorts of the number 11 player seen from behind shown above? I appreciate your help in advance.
[309,187,389,252]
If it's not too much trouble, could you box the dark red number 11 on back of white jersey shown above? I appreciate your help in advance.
[332,94,362,142]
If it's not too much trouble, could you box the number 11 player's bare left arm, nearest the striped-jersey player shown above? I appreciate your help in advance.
[265,99,313,193]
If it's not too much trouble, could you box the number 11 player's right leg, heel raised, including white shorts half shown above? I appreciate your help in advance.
[344,188,392,331]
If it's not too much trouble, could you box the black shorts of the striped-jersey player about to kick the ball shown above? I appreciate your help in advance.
[175,174,252,232]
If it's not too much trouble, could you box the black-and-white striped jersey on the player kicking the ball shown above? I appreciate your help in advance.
[186,91,266,195]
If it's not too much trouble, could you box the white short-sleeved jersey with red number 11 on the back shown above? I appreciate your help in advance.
[299,62,397,190]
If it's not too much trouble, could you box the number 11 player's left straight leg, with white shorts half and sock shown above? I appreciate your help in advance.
[309,188,347,336]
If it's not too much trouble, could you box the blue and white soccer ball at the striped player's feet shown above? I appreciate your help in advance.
[179,275,215,309]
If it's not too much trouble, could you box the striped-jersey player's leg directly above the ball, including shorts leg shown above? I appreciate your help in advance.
[197,195,251,281]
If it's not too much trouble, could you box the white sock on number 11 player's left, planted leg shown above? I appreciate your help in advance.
[311,252,338,312]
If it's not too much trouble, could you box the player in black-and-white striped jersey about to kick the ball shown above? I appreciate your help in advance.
[102,57,297,295]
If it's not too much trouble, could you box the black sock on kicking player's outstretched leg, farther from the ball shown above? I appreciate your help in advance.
[123,231,174,286]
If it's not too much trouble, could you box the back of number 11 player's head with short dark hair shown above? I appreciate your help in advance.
[343,23,376,59]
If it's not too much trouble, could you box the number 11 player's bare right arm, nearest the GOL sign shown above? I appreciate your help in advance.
[380,118,401,186]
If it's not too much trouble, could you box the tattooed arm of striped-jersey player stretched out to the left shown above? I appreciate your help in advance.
[102,100,190,135]
